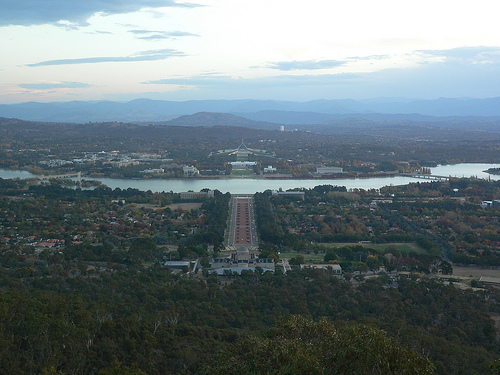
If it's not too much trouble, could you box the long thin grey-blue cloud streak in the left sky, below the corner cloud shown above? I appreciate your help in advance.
[27,49,185,67]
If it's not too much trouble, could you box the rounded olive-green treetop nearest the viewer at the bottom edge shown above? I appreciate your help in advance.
[207,316,434,375]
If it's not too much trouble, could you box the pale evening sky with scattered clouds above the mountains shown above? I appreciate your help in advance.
[0,0,500,104]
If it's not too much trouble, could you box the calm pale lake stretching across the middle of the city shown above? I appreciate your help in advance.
[0,163,500,194]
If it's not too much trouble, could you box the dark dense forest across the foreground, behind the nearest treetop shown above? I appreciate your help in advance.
[0,267,498,374]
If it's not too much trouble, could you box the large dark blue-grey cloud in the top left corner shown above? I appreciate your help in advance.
[0,0,200,26]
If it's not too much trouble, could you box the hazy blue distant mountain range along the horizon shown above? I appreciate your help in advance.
[0,97,500,126]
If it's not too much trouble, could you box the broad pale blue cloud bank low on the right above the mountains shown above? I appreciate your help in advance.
[143,47,500,100]
